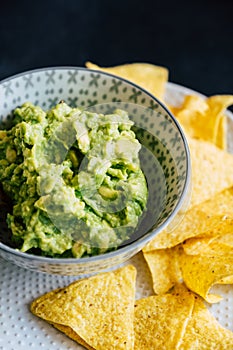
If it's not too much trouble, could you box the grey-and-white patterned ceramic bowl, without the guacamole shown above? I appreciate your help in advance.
[0,67,191,275]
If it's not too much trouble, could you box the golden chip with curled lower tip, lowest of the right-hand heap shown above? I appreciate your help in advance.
[179,247,233,303]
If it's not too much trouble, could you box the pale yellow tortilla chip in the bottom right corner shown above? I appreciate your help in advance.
[179,298,233,350]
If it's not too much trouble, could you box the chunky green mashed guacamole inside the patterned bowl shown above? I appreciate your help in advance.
[0,101,148,257]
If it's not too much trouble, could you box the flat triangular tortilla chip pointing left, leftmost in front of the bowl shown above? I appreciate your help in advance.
[31,265,136,350]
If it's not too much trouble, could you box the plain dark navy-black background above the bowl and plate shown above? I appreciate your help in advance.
[0,0,233,95]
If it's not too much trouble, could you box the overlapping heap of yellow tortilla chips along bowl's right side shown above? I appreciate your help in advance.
[143,91,233,303]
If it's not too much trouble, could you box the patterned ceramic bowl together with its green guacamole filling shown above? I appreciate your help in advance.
[0,67,189,275]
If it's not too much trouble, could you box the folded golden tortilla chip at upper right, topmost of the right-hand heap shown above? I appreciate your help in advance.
[172,95,233,149]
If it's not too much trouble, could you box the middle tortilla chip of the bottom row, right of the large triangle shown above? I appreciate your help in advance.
[134,290,194,350]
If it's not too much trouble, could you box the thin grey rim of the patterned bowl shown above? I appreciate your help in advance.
[0,66,191,265]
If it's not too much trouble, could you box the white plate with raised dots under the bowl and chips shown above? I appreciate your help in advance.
[0,83,233,350]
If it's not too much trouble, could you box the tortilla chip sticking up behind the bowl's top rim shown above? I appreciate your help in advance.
[86,62,168,99]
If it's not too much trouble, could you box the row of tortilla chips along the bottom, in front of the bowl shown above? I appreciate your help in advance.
[31,265,233,350]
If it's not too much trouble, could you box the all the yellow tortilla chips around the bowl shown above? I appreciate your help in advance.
[31,63,233,350]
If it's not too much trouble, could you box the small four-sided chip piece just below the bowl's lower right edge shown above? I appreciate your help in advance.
[143,247,182,294]
